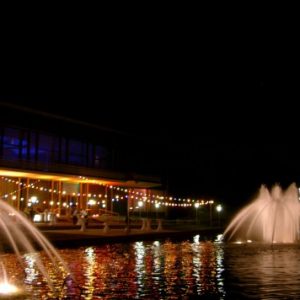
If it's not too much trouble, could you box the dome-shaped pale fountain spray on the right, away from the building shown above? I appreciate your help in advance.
[223,183,300,243]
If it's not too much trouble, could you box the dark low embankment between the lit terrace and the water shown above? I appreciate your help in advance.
[0,224,224,252]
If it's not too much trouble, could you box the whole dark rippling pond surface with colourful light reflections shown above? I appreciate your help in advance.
[0,236,300,299]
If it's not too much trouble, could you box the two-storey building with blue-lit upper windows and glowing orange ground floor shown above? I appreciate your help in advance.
[0,102,163,221]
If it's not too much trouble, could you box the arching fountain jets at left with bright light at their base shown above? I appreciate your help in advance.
[0,200,76,299]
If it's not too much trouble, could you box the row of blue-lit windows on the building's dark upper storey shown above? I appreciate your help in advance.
[0,128,110,168]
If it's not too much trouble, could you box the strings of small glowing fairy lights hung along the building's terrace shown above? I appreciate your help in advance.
[0,176,214,207]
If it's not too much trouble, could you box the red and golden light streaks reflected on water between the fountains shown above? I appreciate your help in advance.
[1,236,225,299]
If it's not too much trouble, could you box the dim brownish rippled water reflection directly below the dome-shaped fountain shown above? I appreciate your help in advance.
[224,244,300,299]
